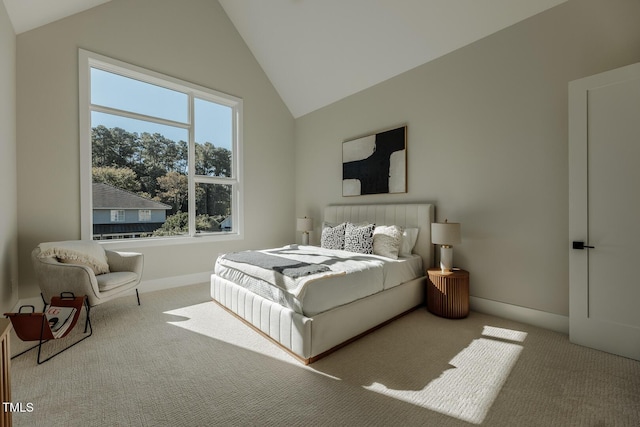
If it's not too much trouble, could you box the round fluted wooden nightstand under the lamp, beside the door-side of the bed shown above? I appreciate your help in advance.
[427,268,469,319]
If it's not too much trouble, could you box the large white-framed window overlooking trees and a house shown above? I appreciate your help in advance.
[79,50,242,242]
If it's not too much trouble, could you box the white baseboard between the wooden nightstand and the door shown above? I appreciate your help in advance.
[470,297,569,335]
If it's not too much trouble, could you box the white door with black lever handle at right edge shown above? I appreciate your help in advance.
[569,64,640,360]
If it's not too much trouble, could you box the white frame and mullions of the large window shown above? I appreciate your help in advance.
[78,49,244,247]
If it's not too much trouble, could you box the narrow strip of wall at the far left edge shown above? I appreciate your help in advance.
[0,2,18,313]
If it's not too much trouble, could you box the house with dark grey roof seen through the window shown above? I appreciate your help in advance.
[93,182,171,240]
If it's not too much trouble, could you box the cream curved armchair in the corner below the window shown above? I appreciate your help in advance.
[31,240,143,307]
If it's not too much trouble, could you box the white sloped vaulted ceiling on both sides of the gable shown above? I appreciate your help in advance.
[3,0,567,118]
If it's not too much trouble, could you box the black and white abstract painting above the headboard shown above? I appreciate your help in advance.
[342,126,407,196]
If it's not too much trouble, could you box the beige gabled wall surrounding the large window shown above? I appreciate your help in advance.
[17,0,295,298]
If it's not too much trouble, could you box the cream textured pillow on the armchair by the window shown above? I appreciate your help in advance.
[39,240,109,274]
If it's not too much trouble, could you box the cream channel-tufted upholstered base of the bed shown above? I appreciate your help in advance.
[211,274,427,364]
